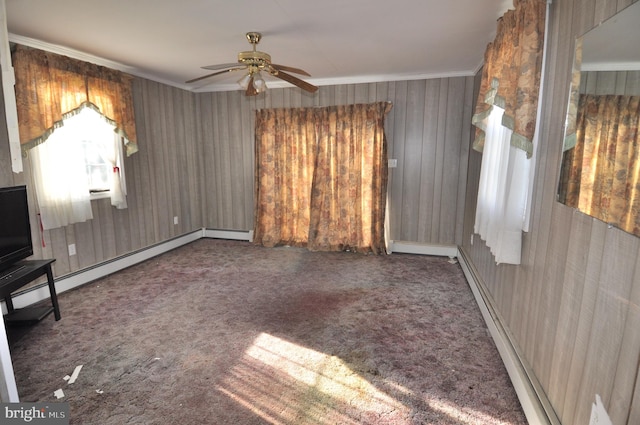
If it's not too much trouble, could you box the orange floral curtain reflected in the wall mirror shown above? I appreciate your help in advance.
[559,94,640,235]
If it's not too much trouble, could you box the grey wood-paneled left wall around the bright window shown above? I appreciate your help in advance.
[0,79,203,276]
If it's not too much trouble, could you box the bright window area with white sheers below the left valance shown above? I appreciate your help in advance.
[29,105,126,229]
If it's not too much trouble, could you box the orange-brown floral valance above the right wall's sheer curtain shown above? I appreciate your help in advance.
[473,0,547,157]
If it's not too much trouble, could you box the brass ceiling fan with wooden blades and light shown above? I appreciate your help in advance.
[186,32,318,96]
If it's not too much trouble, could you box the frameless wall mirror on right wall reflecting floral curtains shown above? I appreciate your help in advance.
[557,1,640,236]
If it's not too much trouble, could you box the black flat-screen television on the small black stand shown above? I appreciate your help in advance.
[0,186,33,274]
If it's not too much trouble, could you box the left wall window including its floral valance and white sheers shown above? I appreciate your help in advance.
[12,44,138,229]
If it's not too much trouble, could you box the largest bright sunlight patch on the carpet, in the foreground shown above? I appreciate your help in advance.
[217,333,408,425]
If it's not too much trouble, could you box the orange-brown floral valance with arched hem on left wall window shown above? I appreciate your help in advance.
[12,45,137,155]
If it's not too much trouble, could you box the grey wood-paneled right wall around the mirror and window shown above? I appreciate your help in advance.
[463,0,640,425]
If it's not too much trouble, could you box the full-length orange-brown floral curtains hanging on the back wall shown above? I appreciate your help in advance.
[254,102,391,254]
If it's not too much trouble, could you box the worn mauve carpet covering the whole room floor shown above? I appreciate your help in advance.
[5,239,526,425]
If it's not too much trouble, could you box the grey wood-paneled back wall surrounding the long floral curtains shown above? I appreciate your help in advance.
[197,77,473,244]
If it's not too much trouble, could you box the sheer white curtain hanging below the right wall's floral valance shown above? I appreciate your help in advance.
[474,106,531,264]
